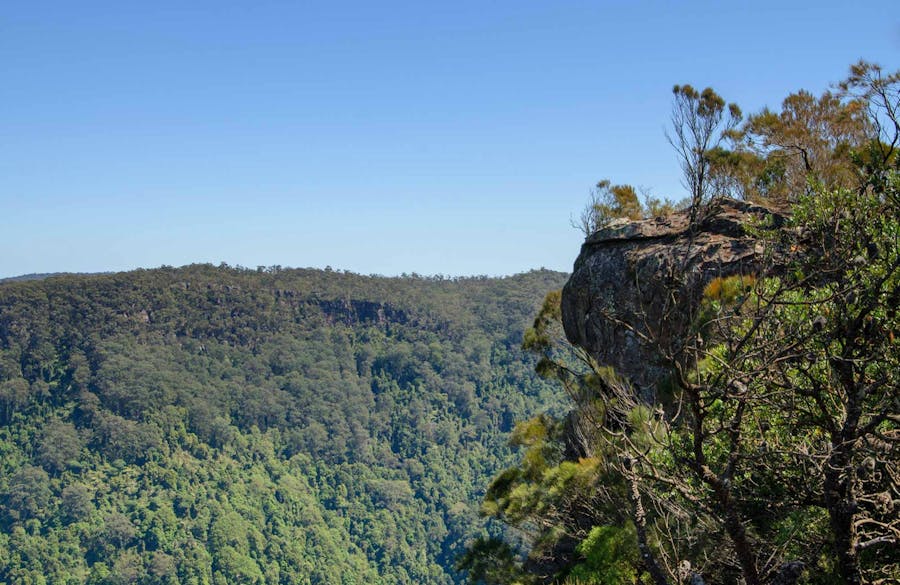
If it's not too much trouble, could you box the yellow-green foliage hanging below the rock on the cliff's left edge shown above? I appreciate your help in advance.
[464,291,636,583]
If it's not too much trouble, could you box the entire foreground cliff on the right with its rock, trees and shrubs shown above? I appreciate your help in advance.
[460,62,900,585]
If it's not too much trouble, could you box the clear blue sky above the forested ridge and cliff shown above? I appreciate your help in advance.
[0,0,900,277]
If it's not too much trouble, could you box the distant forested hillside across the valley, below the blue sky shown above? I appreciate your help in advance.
[0,265,566,585]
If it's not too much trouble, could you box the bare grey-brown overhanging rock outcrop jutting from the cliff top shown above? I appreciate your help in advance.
[562,200,784,395]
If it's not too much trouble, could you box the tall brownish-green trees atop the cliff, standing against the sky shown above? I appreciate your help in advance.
[670,61,900,210]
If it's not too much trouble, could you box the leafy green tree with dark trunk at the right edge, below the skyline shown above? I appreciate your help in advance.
[768,180,900,583]
